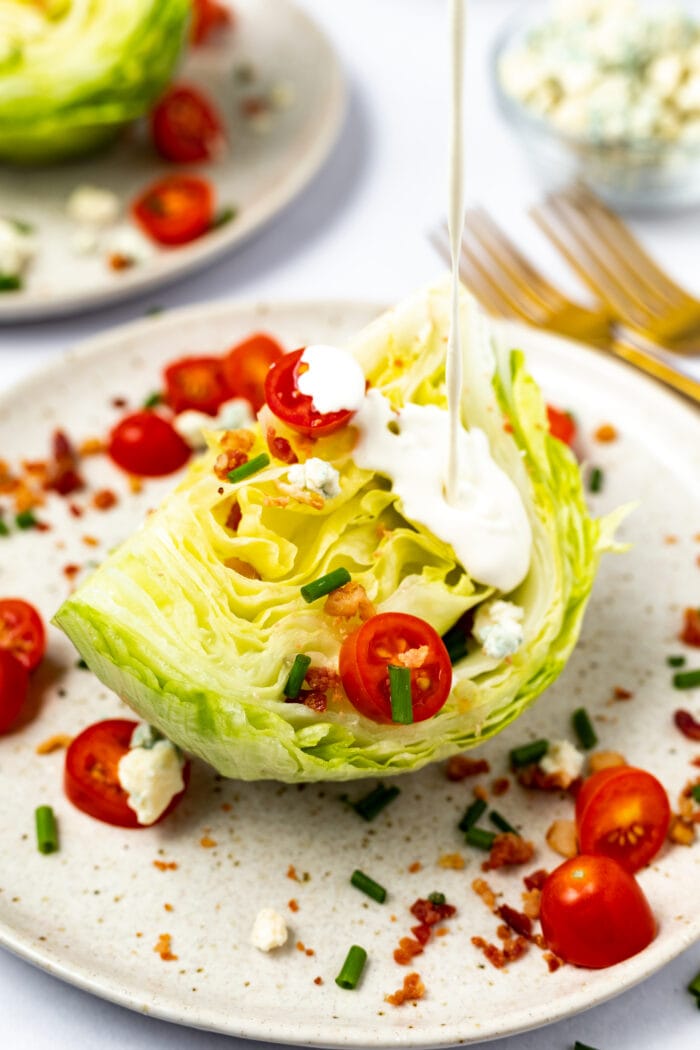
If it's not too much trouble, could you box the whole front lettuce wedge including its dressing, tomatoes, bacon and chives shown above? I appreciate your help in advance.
[56,284,617,782]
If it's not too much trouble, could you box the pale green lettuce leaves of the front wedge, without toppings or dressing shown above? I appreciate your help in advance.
[56,285,615,781]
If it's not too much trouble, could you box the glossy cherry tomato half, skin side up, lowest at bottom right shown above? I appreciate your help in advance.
[539,854,656,969]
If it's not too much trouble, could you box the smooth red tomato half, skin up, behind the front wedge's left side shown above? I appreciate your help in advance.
[107,412,192,478]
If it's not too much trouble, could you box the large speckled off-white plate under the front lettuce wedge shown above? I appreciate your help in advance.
[0,303,700,1047]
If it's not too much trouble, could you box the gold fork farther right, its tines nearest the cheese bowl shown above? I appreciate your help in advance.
[530,186,700,354]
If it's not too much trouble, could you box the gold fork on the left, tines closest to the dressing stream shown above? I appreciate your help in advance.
[429,209,700,404]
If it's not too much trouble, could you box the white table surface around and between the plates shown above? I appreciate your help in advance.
[0,0,700,1050]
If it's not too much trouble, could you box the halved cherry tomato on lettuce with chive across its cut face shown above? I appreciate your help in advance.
[338,612,452,722]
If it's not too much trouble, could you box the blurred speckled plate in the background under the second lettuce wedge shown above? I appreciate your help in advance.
[0,0,345,323]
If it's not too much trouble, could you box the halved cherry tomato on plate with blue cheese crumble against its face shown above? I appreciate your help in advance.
[63,718,190,827]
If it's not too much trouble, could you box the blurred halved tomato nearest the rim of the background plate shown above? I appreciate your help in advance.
[131,175,214,245]
